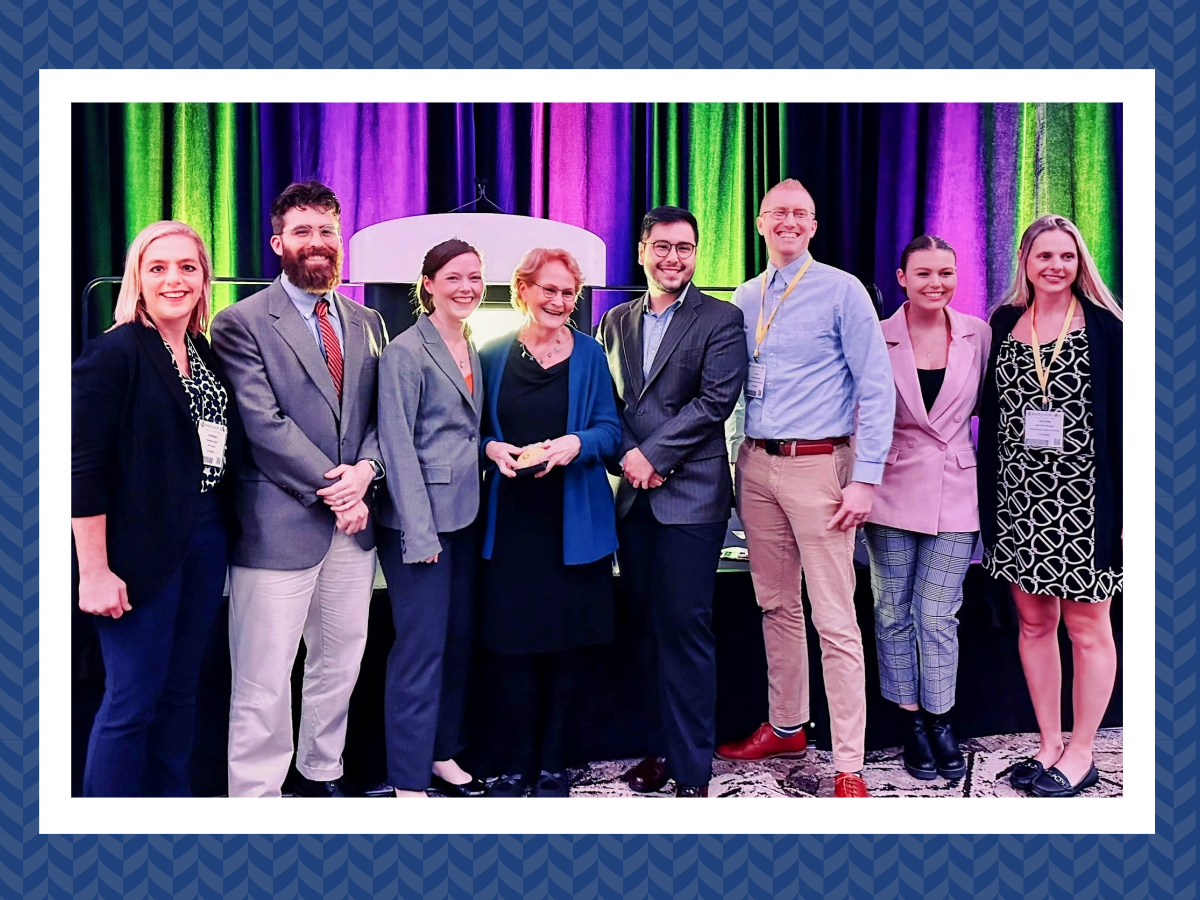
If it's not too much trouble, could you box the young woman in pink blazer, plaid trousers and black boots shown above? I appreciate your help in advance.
[866,235,991,780]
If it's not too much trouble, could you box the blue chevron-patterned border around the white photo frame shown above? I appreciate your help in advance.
[21,0,1196,898]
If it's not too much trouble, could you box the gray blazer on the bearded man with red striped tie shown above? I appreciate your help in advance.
[212,278,388,569]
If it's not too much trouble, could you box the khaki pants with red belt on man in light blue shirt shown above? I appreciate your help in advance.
[737,442,866,772]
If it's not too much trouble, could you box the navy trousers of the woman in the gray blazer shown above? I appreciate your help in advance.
[376,526,478,791]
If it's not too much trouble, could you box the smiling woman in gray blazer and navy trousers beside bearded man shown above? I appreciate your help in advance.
[376,240,486,797]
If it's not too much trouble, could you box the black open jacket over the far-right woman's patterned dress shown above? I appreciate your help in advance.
[977,298,1124,569]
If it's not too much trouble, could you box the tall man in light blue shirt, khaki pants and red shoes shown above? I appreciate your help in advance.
[718,179,895,797]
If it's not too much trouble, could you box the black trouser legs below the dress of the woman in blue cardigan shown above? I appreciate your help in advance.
[490,650,578,778]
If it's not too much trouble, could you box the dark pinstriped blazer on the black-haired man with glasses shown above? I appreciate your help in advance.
[598,284,748,524]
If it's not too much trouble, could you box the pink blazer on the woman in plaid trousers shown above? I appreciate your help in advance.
[868,304,991,534]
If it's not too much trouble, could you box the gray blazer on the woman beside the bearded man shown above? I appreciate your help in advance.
[378,316,484,563]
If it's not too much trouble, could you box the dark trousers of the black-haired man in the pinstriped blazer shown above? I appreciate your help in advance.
[617,491,726,785]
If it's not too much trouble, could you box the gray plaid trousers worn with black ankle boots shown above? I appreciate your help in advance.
[866,524,978,714]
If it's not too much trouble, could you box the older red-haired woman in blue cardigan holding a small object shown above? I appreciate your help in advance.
[480,248,620,797]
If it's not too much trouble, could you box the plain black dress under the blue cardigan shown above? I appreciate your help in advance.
[480,341,613,654]
